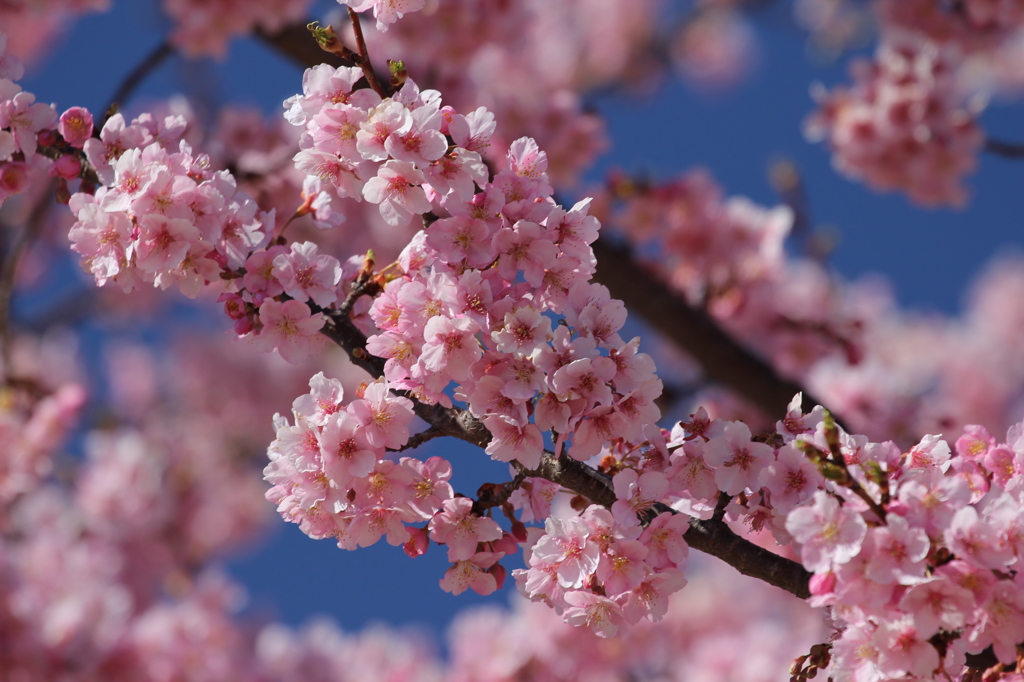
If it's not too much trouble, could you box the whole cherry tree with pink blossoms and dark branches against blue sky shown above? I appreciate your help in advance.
[6,0,1024,682]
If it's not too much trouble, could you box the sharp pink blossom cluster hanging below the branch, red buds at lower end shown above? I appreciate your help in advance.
[264,373,517,594]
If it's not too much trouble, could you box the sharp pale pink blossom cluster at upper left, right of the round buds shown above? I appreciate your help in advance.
[69,106,274,297]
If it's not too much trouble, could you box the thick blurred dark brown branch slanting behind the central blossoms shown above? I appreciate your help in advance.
[593,233,846,428]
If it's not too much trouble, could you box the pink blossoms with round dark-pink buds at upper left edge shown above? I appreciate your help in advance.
[0,33,92,206]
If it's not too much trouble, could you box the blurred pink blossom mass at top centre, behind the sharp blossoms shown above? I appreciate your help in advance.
[356,0,662,186]
